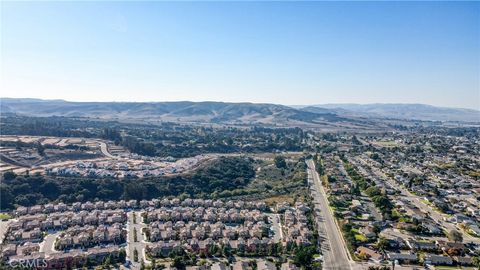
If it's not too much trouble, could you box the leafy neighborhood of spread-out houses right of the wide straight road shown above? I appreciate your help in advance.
[316,131,480,267]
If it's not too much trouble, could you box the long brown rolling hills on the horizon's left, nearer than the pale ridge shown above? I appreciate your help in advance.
[0,98,340,124]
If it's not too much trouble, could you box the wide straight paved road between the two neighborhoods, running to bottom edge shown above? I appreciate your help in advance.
[307,159,356,270]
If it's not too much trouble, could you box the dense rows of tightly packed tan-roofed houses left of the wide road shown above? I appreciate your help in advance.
[1,198,313,269]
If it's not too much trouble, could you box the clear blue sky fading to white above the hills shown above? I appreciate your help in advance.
[0,1,480,109]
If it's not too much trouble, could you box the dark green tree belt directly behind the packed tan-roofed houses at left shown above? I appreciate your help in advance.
[0,157,255,209]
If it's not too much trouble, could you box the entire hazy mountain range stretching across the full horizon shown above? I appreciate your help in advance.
[0,98,480,125]
